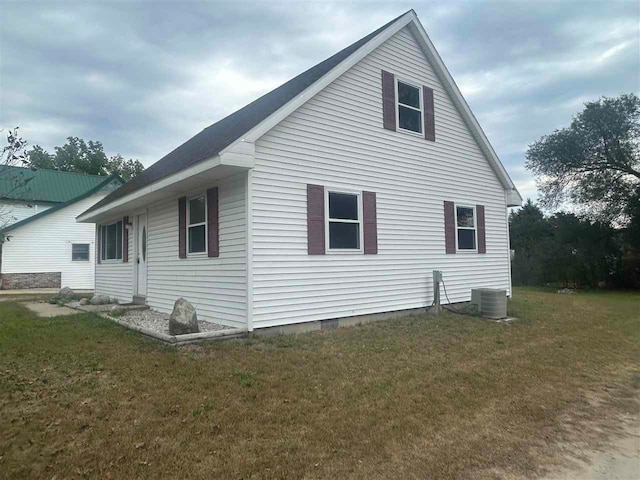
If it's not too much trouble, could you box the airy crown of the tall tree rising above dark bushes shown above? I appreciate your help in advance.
[526,94,640,225]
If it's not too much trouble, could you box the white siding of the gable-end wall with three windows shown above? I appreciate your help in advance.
[252,29,510,328]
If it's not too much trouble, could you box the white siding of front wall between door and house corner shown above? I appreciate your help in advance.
[147,174,247,327]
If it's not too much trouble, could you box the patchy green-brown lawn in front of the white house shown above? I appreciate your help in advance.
[0,289,640,479]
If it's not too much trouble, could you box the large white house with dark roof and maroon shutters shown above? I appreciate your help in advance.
[78,11,522,330]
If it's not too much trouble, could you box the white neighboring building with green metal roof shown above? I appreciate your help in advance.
[0,167,123,290]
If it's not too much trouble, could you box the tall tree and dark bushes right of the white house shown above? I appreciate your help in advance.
[509,94,640,288]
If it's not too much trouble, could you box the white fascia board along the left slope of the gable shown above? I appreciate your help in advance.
[220,11,416,155]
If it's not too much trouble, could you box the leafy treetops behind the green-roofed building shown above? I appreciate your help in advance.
[29,137,144,180]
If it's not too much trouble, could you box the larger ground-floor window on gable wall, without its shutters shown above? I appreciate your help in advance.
[328,192,361,250]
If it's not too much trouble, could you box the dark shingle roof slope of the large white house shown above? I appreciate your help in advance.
[85,13,406,213]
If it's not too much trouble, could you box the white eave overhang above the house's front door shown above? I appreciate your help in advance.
[76,152,254,223]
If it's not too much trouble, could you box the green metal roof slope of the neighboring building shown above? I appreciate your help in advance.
[0,165,112,203]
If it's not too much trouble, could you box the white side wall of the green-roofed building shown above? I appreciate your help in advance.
[2,193,105,289]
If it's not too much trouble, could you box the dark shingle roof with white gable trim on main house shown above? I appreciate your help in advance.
[81,10,522,216]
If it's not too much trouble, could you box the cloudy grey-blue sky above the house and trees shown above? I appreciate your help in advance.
[0,0,640,198]
